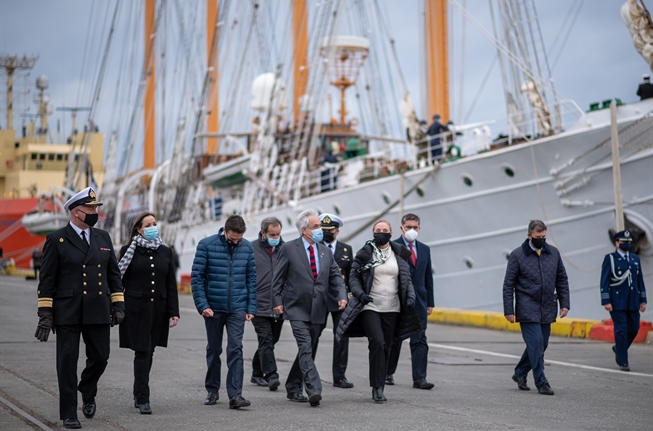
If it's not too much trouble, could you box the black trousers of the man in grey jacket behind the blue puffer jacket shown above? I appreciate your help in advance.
[252,316,283,379]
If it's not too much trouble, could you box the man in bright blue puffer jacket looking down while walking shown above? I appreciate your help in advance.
[191,215,256,409]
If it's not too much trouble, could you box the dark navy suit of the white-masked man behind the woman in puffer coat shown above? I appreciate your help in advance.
[388,237,435,381]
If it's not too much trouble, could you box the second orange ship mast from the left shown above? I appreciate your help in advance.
[206,0,220,155]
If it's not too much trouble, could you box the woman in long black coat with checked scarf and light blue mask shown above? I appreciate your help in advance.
[118,213,179,414]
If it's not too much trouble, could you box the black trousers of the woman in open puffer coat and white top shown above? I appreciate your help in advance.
[359,310,399,388]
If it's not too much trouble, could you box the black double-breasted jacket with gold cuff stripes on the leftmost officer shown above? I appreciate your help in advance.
[38,223,124,326]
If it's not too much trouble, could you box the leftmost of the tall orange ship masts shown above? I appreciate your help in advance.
[143,0,156,169]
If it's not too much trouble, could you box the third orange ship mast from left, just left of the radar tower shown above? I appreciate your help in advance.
[292,0,308,124]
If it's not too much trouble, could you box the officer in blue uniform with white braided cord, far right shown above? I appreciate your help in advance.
[601,230,646,371]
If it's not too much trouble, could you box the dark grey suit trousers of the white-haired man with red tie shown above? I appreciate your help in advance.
[286,320,324,396]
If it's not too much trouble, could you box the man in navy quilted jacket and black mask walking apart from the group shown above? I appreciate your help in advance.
[503,220,569,395]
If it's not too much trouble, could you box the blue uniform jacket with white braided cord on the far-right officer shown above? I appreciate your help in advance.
[601,251,646,311]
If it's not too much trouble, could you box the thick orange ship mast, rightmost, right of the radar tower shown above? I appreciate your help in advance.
[424,0,451,124]
